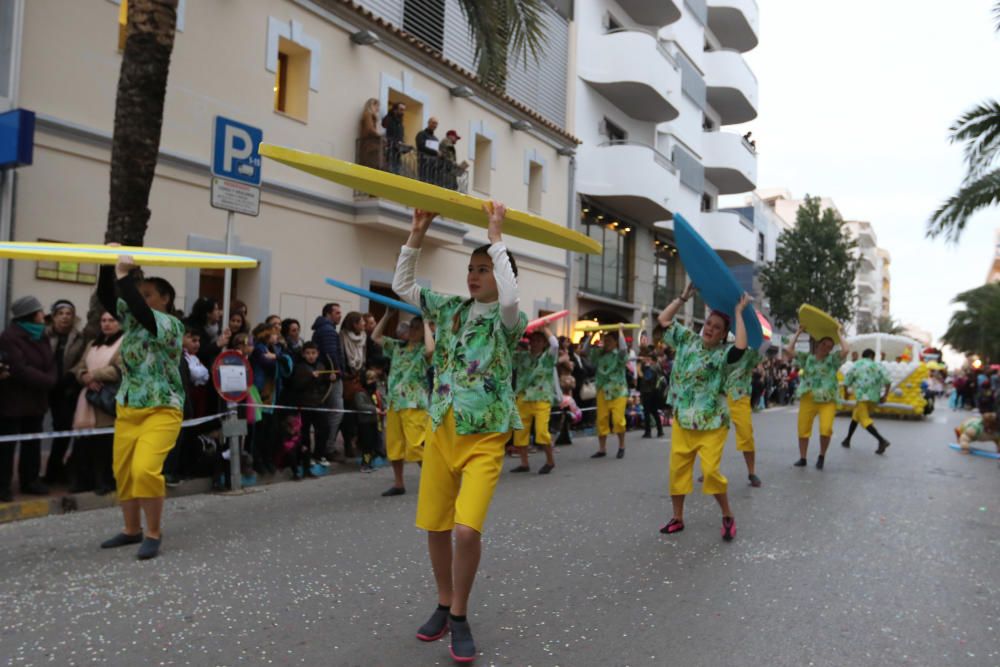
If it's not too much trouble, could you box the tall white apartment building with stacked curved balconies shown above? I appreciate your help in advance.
[569,0,758,332]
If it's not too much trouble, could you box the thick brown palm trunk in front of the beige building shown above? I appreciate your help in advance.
[104,0,177,245]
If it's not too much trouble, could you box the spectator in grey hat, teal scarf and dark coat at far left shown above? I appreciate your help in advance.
[0,296,59,502]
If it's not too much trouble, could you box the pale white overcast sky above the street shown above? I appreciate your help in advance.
[727,0,1000,337]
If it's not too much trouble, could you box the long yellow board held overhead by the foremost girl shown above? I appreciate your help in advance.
[260,144,602,255]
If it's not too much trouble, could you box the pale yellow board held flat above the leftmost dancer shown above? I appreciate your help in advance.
[0,241,257,269]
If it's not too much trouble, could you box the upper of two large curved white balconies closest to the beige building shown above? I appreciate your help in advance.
[578,30,681,123]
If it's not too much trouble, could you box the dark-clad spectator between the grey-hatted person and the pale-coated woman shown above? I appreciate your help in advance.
[45,299,84,484]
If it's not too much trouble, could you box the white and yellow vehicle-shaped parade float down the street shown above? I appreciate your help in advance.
[838,333,930,419]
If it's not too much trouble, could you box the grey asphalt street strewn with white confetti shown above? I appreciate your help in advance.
[0,409,1000,667]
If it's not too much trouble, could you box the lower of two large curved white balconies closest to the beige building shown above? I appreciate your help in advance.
[577,142,680,223]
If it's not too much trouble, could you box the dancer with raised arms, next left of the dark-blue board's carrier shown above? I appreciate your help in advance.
[582,325,628,459]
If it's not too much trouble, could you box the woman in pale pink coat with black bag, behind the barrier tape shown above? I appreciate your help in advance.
[70,311,122,495]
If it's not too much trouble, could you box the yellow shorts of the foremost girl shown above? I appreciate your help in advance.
[417,409,510,533]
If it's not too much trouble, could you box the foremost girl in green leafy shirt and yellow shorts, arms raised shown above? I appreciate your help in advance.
[392,202,527,663]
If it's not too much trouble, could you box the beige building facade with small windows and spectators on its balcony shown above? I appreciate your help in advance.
[8,0,576,330]
